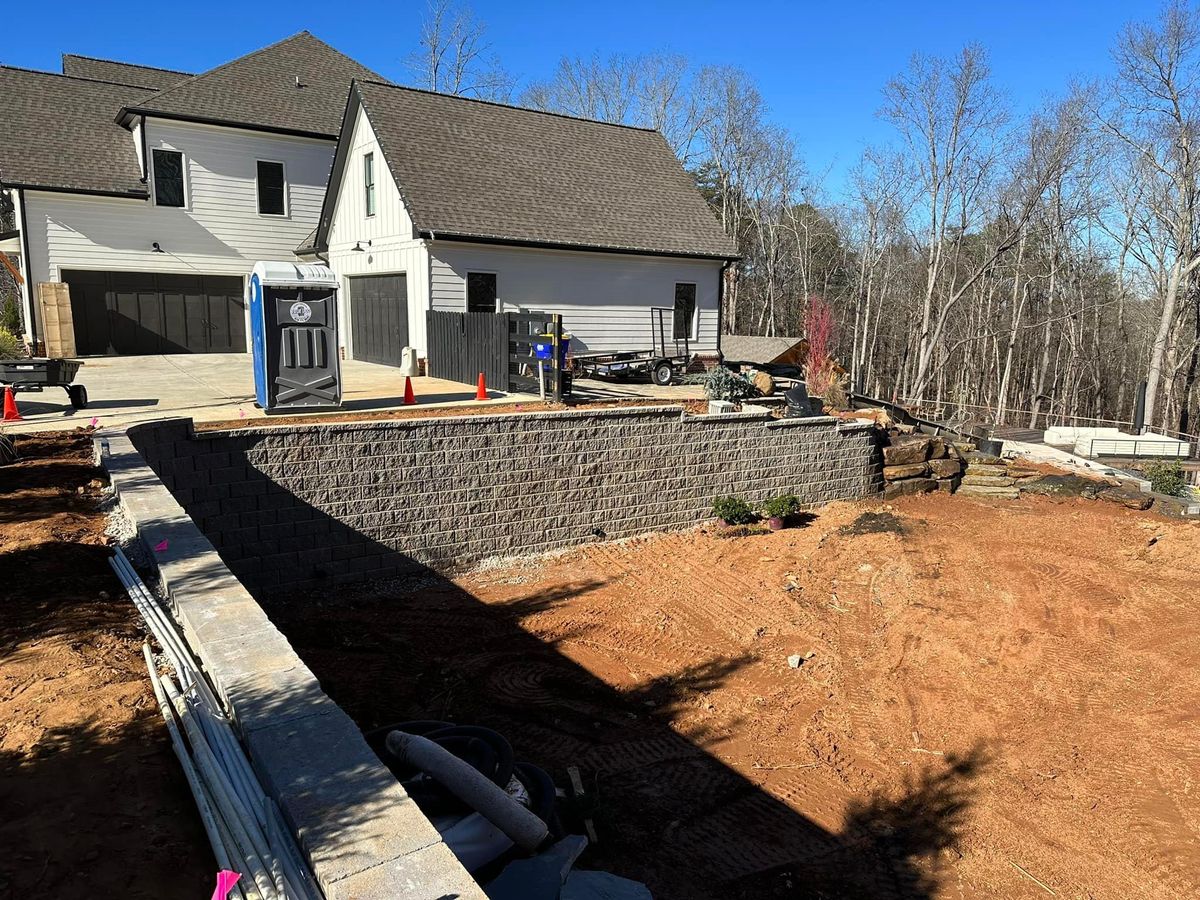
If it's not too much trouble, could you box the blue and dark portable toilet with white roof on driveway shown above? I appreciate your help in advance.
[248,262,342,413]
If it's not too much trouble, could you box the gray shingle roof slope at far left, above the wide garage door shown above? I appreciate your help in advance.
[0,66,148,197]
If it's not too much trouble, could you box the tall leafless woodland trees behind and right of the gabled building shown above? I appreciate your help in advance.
[414,0,1200,432]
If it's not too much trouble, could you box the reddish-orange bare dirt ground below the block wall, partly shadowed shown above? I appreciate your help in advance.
[270,494,1200,900]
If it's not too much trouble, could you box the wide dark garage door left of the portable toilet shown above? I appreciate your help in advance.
[62,271,246,356]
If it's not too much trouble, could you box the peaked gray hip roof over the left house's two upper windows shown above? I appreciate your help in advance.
[128,31,379,137]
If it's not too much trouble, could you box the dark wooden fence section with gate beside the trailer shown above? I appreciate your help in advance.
[426,310,563,400]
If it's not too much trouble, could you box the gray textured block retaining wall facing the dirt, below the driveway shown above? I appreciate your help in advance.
[128,407,882,590]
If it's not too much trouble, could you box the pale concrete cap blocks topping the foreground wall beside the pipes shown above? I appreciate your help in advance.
[94,420,485,900]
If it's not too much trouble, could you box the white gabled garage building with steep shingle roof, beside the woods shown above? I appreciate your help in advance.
[307,79,736,365]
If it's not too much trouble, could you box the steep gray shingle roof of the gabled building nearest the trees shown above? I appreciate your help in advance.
[343,82,737,257]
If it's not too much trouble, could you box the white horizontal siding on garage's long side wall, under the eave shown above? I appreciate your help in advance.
[430,241,721,353]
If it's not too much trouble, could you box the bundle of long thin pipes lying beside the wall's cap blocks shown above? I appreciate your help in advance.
[109,550,322,900]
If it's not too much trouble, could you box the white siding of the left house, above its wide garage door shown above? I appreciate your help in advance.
[26,119,334,283]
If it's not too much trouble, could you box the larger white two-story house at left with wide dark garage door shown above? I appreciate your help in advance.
[0,32,378,355]
